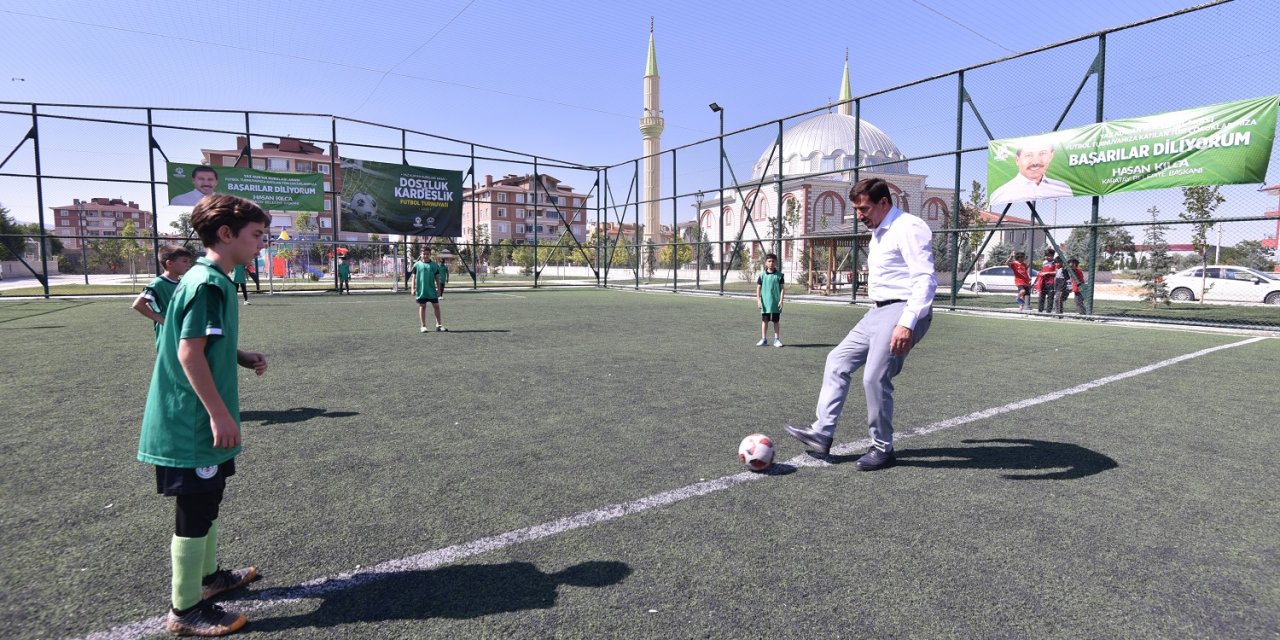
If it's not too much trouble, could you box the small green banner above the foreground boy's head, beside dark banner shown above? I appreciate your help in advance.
[168,163,324,211]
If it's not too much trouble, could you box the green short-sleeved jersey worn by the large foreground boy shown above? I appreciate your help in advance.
[138,257,241,468]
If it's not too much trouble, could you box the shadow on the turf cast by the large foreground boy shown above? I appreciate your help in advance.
[251,561,631,632]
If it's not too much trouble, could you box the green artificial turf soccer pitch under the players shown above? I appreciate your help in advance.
[0,291,1280,639]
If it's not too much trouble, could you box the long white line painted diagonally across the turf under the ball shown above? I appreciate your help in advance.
[74,337,1268,640]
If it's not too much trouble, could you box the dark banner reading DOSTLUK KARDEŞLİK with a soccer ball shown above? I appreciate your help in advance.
[342,157,462,238]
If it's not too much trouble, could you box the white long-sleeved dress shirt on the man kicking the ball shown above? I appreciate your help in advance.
[867,206,938,329]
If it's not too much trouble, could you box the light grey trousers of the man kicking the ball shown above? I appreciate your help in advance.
[813,302,933,449]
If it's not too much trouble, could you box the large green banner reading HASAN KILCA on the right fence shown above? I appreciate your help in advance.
[987,96,1280,206]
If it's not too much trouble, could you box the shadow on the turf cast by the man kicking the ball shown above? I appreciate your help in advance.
[827,438,1120,480]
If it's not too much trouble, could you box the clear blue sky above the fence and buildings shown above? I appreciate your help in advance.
[0,0,1280,238]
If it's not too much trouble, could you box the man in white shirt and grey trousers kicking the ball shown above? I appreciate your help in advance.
[786,178,938,471]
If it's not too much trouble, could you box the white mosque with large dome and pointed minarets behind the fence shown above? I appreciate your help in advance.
[641,32,955,269]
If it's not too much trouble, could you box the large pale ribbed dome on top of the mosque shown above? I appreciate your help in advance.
[751,113,908,179]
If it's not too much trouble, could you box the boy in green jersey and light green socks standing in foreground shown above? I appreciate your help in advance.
[138,193,271,636]
